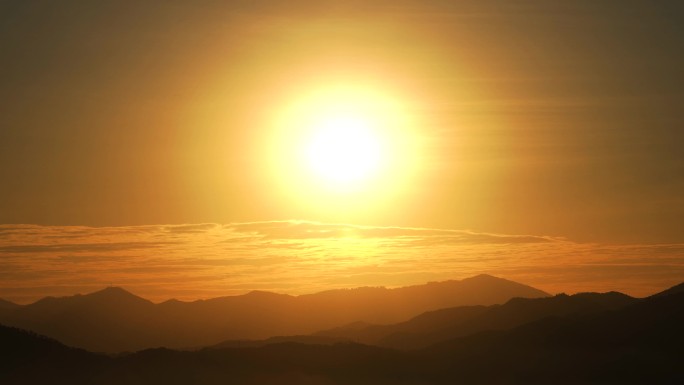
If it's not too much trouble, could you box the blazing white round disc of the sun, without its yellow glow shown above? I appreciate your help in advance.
[305,113,385,188]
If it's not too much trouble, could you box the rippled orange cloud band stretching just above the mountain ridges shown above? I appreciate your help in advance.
[0,221,684,303]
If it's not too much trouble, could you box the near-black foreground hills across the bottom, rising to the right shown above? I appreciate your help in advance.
[0,284,684,384]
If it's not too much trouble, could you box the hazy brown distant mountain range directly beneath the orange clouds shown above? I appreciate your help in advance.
[0,275,548,352]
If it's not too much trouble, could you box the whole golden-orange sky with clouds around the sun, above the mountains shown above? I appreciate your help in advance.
[0,0,684,302]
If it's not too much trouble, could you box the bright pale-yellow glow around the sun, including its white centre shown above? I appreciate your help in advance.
[268,84,420,216]
